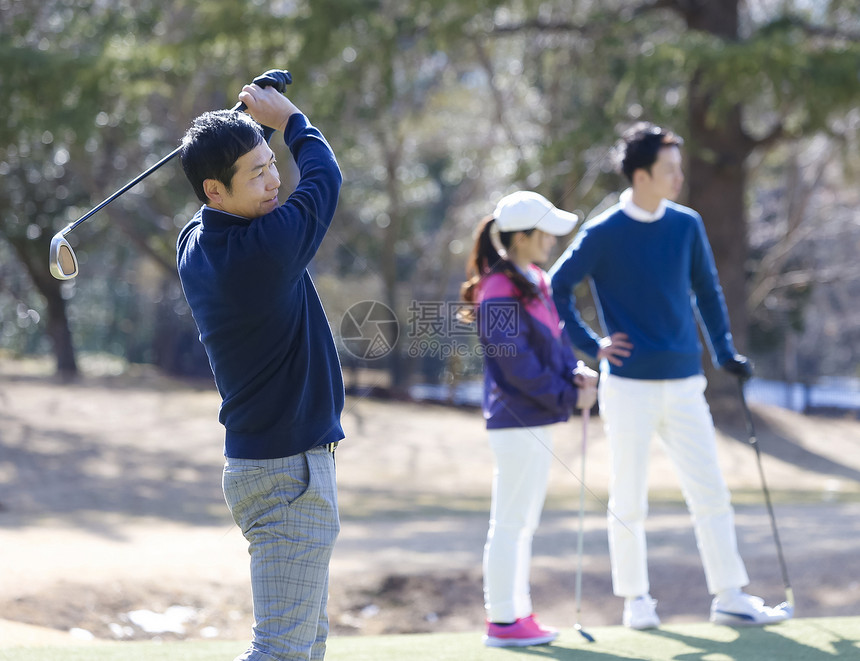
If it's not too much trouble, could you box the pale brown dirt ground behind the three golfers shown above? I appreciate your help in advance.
[0,360,860,639]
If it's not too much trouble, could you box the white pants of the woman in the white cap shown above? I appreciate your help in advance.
[484,426,553,622]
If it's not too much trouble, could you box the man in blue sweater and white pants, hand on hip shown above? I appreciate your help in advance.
[550,124,789,629]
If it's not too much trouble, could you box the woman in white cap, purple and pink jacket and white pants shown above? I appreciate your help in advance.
[462,191,597,647]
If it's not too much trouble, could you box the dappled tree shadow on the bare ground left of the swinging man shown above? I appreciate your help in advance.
[0,413,229,537]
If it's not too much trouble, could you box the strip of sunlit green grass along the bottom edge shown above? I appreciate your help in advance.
[0,616,860,661]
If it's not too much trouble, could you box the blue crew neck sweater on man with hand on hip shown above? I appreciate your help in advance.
[550,202,735,379]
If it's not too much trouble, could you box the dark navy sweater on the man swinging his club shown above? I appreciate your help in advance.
[177,114,344,459]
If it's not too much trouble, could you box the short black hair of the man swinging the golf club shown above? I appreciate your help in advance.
[179,110,263,204]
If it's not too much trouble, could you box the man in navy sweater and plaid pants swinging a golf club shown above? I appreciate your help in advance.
[177,80,344,661]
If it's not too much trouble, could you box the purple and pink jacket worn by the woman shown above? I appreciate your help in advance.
[476,265,577,429]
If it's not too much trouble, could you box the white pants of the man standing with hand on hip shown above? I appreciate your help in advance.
[599,373,749,597]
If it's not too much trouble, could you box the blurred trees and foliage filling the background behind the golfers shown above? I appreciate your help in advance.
[0,0,860,398]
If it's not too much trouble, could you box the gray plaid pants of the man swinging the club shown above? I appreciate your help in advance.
[223,447,340,661]
